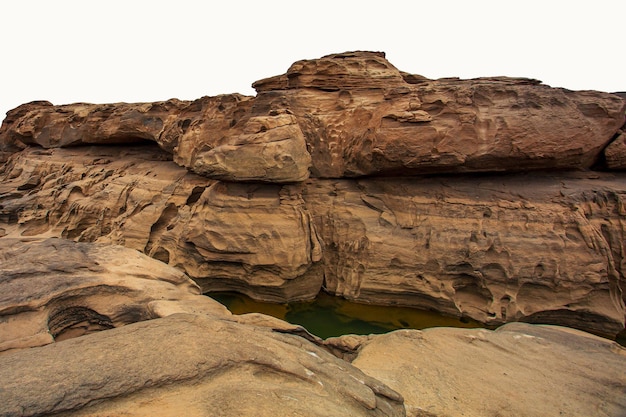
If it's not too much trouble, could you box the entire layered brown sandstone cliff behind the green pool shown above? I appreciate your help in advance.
[0,52,626,336]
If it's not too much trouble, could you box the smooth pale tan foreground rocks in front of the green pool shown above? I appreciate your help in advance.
[0,238,626,417]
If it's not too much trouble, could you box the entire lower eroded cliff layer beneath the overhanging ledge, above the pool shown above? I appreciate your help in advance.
[0,146,626,336]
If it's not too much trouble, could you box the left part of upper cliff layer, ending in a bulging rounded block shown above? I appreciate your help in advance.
[0,94,311,183]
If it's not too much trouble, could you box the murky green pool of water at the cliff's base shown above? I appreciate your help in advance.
[207,292,484,339]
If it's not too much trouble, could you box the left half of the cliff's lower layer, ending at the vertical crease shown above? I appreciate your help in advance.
[0,145,322,301]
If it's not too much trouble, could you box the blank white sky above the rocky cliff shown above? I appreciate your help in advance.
[0,0,626,119]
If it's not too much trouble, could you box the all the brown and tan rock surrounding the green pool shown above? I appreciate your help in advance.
[0,52,626,416]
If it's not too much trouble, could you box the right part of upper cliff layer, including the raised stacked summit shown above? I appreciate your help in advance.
[253,52,626,177]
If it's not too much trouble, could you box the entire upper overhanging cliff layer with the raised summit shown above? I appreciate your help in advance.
[0,52,626,183]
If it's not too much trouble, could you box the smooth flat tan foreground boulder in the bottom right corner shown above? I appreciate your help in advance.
[352,323,626,417]
